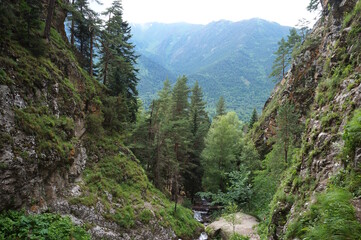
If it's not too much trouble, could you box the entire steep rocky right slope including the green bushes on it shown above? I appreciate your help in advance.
[252,0,361,239]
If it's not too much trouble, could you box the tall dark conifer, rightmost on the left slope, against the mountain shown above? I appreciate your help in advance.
[99,0,138,122]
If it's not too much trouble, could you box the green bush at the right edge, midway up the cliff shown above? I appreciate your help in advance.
[343,109,361,159]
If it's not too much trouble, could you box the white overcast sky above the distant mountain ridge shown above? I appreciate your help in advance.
[91,0,315,26]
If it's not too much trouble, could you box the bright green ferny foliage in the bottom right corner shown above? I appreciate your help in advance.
[286,188,361,240]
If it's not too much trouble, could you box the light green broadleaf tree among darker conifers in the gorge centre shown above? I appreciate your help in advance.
[201,112,242,193]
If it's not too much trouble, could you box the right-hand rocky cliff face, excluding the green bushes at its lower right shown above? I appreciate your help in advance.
[253,0,361,239]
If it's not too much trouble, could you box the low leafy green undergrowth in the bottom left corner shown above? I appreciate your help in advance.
[0,211,91,240]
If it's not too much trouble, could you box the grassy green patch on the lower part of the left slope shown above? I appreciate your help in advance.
[71,133,201,239]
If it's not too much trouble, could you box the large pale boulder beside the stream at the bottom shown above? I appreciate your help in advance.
[207,213,260,240]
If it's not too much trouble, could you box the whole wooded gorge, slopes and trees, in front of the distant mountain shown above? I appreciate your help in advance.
[0,0,361,240]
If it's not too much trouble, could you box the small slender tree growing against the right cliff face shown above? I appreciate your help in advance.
[276,102,301,163]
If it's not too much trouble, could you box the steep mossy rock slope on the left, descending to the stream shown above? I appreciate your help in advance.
[0,1,199,239]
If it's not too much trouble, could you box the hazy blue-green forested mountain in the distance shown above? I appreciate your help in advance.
[132,19,289,120]
